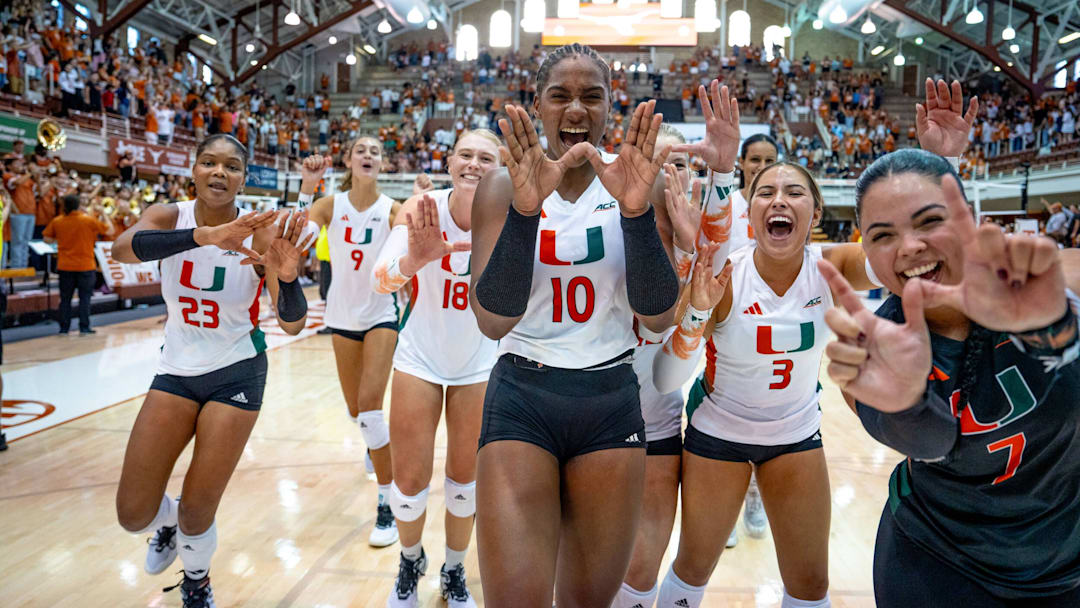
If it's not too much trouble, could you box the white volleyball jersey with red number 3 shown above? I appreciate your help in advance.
[690,247,833,445]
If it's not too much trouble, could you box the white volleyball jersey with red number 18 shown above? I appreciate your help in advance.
[394,190,498,386]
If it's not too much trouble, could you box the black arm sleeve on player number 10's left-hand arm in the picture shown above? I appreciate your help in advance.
[476,205,540,316]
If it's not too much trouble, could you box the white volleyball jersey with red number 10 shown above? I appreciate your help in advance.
[499,171,637,369]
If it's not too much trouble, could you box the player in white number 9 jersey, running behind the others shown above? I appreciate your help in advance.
[300,136,401,546]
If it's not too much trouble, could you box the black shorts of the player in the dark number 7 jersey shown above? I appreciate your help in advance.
[874,503,1080,608]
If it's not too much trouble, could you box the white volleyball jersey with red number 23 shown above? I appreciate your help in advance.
[158,201,266,376]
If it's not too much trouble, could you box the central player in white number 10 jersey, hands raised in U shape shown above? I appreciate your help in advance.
[470,44,678,608]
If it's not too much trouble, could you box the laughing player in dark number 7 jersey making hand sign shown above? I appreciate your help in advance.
[822,79,1080,608]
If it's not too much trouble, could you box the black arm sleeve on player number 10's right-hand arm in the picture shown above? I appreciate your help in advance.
[621,207,678,316]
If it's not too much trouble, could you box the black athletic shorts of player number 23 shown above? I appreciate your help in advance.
[150,352,267,411]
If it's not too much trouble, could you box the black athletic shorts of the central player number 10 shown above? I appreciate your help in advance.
[480,354,646,464]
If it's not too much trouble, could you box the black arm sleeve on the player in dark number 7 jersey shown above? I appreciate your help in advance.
[855,391,959,460]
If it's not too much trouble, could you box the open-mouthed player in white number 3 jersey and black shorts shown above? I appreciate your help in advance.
[653,150,870,607]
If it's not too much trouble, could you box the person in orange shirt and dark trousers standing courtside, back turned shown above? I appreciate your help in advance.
[44,194,114,336]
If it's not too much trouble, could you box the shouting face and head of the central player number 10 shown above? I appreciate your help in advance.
[532,55,610,159]
